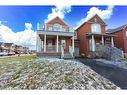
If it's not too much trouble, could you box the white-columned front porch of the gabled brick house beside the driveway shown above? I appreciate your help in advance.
[86,33,115,58]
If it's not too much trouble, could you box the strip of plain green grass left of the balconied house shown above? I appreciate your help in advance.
[0,55,36,63]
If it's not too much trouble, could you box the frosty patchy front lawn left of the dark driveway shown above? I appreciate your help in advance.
[0,56,119,90]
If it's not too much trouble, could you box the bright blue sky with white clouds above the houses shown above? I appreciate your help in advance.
[0,5,127,49]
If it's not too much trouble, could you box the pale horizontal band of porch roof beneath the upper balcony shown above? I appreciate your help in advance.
[37,30,74,37]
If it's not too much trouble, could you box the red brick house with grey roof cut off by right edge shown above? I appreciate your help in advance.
[107,24,127,53]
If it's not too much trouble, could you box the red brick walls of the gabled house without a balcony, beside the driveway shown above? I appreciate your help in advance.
[76,15,106,56]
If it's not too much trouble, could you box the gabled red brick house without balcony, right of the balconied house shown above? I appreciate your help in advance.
[75,14,115,57]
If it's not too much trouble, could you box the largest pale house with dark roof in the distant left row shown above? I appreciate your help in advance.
[4,43,15,55]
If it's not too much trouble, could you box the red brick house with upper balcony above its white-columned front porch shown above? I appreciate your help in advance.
[36,17,74,58]
